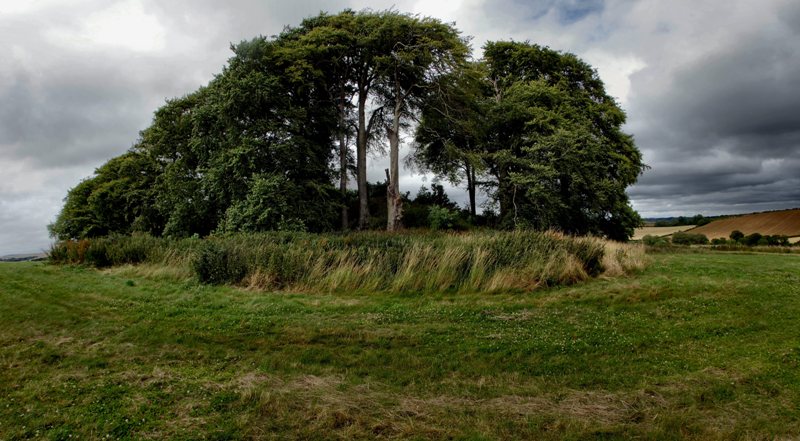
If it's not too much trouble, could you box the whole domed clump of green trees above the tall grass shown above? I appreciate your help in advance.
[50,10,645,239]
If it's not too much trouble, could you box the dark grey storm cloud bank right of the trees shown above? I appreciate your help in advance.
[629,0,800,212]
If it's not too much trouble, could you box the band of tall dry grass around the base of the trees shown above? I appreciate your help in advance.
[51,231,646,292]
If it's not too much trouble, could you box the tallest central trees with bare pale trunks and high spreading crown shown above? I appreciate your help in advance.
[284,10,468,229]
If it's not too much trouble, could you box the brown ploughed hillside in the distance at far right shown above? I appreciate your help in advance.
[689,208,800,239]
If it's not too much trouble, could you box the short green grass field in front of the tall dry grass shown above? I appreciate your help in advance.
[0,253,800,440]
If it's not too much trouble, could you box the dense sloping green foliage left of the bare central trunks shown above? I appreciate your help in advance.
[51,29,340,239]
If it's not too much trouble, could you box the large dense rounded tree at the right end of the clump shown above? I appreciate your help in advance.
[484,42,646,240]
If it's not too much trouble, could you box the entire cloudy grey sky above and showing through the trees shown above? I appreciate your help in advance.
[0,0,800,255]
